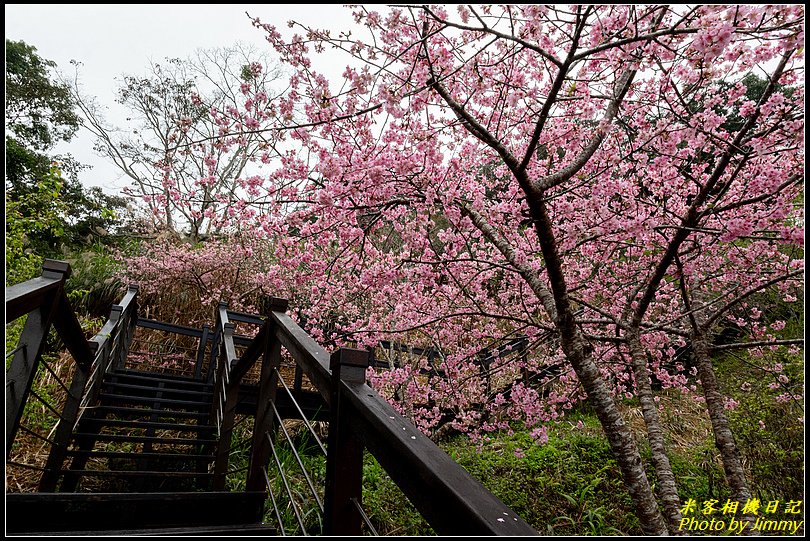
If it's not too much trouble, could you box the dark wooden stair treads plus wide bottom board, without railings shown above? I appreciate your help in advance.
[6,364,276,535]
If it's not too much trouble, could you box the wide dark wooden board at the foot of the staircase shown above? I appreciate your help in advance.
[6,490,265,534]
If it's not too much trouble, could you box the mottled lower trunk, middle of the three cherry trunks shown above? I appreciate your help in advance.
[626,329,682,534]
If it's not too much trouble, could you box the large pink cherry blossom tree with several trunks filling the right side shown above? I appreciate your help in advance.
[128,6,804,534]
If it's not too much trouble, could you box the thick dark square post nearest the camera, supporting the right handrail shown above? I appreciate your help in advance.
[324,348,369,535]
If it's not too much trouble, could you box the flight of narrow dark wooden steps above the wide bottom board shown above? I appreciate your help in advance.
[60,370,217,492]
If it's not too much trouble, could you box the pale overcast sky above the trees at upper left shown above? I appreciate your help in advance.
[5,4,352,192]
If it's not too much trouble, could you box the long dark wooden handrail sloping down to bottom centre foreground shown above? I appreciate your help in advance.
[258,304,538,535]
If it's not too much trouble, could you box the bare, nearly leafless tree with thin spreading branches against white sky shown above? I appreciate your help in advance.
[73,45,278,242]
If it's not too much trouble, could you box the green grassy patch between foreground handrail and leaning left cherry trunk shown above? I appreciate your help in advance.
[438,415,640,535]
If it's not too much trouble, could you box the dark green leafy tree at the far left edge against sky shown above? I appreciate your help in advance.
[5,39,124,255]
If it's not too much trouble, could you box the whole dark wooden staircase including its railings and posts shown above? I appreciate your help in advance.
[5,260,536,537]
